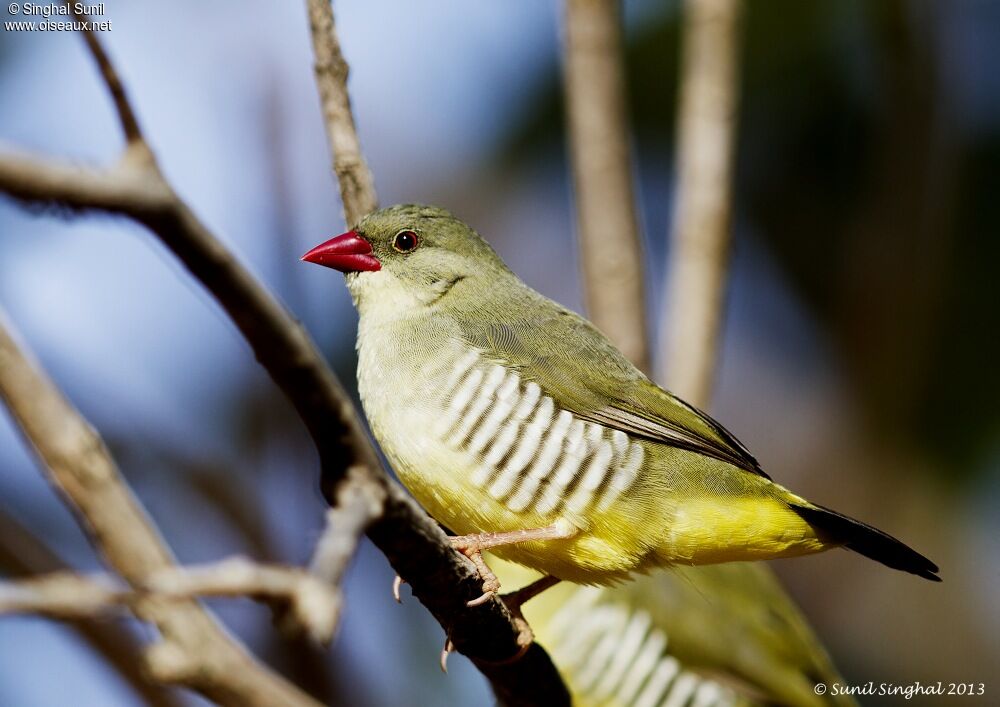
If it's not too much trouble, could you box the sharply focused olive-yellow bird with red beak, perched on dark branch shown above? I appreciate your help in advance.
[302,204,940,605]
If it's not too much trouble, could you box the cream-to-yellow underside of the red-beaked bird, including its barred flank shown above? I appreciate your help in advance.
[359,338,822,584]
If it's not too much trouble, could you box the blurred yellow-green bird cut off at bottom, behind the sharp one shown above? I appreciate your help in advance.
[490,558,857,707]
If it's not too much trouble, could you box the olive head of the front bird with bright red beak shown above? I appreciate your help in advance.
[302,204,511,315]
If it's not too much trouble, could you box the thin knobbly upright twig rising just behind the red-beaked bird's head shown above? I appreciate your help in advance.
[306,0,378,228]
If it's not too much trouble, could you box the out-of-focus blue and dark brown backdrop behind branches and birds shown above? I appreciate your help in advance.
[0,0,1000,707]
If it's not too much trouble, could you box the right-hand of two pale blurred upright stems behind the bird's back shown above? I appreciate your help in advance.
[660,0,740,406]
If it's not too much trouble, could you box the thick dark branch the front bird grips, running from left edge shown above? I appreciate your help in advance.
[0,9,569,705]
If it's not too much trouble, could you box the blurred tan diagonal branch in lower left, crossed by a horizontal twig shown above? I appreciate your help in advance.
[0,318,315,706]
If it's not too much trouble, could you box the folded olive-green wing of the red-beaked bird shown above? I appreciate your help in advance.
[459,293,769,478]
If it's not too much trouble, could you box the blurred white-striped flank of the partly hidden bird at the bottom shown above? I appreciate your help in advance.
[544,587,738,707]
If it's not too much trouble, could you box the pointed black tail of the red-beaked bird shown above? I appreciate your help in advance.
[791,505,941,582]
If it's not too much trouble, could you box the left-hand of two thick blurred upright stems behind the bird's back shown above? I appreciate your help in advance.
[564,0,649,370]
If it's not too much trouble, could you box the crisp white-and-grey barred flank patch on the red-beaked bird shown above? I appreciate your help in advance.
[436,350,645,515]
